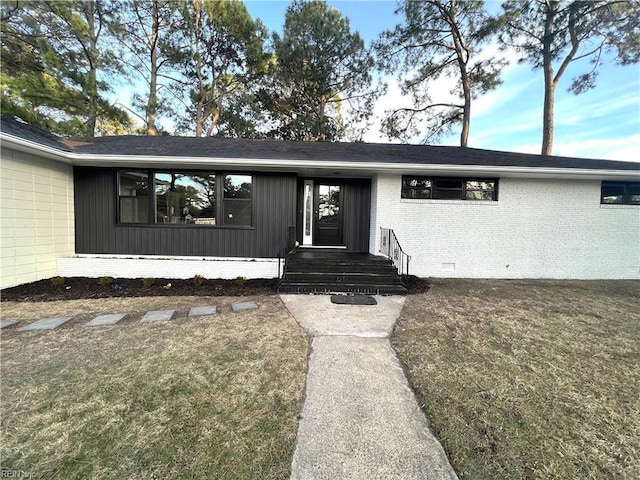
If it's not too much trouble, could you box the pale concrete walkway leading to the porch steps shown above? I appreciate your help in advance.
[281,295,458,480]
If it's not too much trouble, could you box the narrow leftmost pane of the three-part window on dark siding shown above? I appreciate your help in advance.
[118,170,149,223]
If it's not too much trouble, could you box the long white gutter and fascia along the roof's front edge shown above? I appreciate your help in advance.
[1,133,640,180]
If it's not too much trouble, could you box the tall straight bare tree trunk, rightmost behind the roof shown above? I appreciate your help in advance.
[540,1,557,155]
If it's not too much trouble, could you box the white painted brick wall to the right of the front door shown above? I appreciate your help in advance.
[371,175,640,279]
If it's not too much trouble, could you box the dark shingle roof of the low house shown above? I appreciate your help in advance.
[1,118,640,171]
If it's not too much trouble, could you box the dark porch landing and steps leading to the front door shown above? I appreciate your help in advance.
[278,248,407,295]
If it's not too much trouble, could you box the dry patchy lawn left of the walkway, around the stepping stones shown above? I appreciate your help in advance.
[0,296,308,479]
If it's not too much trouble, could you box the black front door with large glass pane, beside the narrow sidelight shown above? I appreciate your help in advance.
[313,182,344,246]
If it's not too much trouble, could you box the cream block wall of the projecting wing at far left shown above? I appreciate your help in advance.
[0,148,74,288]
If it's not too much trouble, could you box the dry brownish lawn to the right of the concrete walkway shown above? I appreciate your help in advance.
[393,280,640,479]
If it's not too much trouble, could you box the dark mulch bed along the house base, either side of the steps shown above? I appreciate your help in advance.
[0,276,430,302]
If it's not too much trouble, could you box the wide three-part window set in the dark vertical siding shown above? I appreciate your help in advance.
[118,170,253,227]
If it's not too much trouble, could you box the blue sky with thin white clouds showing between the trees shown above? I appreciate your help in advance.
[245,0,640,161]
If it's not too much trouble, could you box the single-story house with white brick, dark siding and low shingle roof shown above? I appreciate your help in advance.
[0,118,640,288]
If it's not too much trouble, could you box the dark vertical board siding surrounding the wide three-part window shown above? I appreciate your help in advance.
[74,167,297,257]
